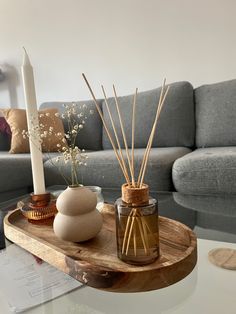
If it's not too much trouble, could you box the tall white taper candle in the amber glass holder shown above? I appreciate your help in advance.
[21,48,45,194]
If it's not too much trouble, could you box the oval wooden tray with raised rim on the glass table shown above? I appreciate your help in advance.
[4,205,197,292]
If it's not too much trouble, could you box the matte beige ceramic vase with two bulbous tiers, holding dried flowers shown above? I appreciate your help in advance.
[53,186,103,242]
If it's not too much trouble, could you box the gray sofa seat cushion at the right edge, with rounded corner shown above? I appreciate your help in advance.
[172,147,236,194]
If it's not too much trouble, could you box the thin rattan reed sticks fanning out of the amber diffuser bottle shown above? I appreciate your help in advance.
[82,73,169,256]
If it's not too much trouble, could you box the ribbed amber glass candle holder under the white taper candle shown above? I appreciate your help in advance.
[18,193,57,223]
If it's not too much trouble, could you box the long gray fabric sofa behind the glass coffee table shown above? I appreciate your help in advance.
[0,80,236,202]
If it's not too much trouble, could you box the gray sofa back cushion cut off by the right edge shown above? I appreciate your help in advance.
[195,80,236,147]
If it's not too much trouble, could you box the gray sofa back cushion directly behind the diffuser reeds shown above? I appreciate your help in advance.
[102,82,195,149]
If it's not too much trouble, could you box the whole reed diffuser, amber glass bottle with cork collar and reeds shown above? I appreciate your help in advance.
[82,74,169,265]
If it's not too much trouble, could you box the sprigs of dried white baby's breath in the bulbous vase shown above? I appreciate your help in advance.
[22,103,93,186]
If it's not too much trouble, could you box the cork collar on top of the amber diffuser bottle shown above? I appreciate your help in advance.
[121,183,149,206]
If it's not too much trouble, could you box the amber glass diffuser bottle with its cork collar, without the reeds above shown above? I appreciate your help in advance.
[115,184,159,265]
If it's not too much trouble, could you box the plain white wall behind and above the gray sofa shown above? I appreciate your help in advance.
[0,0,236,107]
